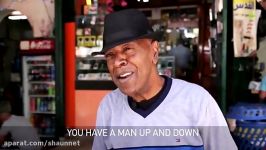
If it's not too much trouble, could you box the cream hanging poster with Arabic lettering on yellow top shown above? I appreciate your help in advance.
[233,0,260,57]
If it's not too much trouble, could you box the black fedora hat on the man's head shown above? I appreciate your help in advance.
[92,9,162,55]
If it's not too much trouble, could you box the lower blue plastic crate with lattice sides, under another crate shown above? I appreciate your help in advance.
[233,121,266,150]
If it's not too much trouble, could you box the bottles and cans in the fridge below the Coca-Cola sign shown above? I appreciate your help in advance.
[23,55,56,137]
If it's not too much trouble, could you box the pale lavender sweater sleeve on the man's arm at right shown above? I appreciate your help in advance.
[200,93,238,150]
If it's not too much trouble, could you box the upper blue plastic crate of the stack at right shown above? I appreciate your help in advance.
[226,103,266,120]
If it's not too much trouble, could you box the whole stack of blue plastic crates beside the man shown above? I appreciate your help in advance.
[226,103,266,150]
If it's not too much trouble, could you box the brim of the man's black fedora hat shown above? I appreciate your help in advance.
[91,31,163,56]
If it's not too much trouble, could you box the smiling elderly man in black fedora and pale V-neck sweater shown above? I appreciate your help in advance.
[92,9,237,150]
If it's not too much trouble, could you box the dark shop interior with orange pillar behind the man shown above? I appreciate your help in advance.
[0,0,266,149]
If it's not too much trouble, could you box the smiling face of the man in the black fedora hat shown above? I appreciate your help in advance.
[105,39,158,97]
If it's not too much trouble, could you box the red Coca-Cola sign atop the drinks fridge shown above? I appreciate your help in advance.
[20,39,55,50]
